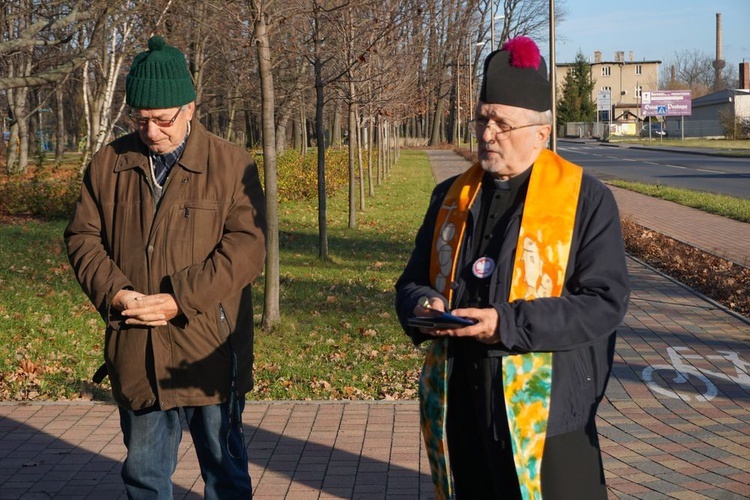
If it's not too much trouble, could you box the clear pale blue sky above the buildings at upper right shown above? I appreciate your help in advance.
[544,0,750,73]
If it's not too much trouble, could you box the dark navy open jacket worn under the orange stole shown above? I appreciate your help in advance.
[396,165,629,436]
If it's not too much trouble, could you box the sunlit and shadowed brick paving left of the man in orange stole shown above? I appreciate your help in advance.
[0,401,432,500]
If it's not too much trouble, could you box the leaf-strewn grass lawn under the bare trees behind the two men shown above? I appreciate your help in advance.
[0,150,434,401]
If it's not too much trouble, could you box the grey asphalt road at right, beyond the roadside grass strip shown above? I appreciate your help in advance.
[557,141,750,198]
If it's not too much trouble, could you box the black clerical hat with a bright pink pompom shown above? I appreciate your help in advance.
[479,36,552,111]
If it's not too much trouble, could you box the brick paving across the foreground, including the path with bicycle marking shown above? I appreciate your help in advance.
[0,152,750,500]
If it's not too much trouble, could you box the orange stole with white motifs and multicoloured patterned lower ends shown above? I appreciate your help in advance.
[419,150,583,499]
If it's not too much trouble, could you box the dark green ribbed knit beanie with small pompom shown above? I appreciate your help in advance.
[125,35,195,109]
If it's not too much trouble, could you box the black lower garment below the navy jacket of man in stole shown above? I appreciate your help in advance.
[447,358,607,500]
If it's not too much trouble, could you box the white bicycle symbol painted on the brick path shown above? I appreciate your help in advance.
[641,347,750,402]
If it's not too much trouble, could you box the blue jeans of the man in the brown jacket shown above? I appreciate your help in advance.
[120,398,253,500]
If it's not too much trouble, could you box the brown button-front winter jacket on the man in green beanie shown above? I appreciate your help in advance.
[65,120,266,410]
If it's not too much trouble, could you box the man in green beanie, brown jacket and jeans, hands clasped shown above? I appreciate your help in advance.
[65,36,266,499]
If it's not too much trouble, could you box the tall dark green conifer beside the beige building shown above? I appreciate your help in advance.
[557,52,596,128]
